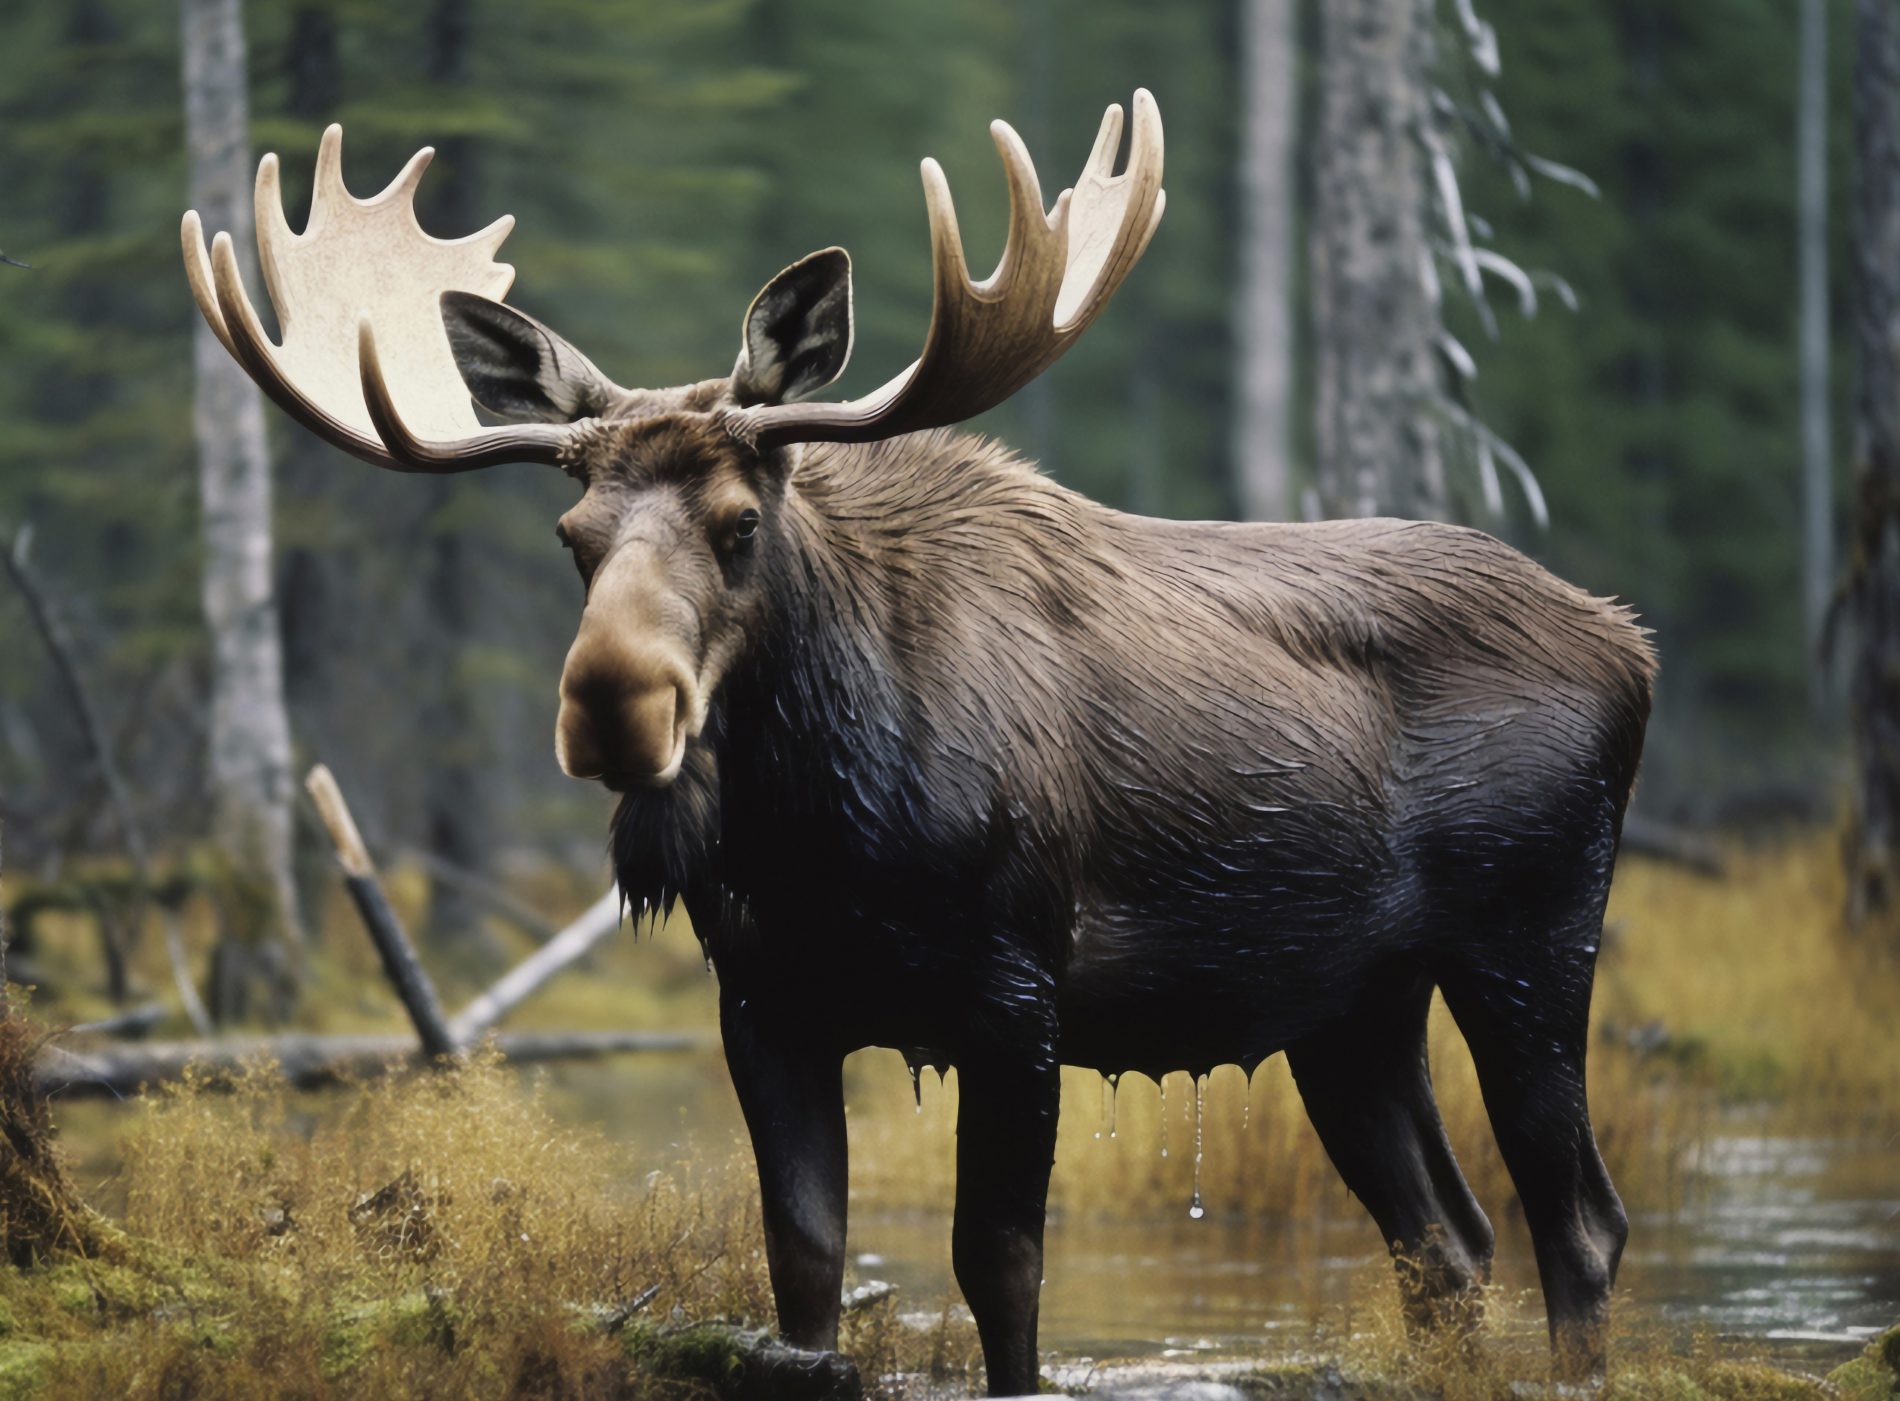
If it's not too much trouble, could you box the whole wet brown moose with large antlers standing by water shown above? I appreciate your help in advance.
[182,91,1655,1395]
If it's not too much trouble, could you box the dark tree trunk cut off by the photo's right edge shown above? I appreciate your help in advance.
[1847,0,1900,922]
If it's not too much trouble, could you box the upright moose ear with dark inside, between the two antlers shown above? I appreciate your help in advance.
[732,249,851,407]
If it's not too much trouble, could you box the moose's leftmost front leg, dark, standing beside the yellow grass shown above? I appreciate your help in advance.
[720,996,847,1350]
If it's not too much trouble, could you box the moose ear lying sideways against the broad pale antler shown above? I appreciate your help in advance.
[443,291,621,424]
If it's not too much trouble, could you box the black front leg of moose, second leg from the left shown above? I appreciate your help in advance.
[950,1055,1062,1395]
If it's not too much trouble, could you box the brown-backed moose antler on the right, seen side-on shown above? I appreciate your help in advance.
[732,87,1167,447]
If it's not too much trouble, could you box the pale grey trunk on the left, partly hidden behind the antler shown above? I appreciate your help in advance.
[179,0,300,990]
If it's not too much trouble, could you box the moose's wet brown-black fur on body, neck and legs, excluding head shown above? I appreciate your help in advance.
[614,433,1655,1388]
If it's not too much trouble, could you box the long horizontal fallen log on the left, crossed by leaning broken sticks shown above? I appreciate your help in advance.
[34,1030,711,1099]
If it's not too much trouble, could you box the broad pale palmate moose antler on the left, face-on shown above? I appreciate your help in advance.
[181,125,568,471]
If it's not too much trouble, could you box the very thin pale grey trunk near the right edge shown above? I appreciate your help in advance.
[1796,0,1834,715]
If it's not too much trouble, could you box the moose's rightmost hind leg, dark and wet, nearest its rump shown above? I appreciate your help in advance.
[1440,935,1630,1380]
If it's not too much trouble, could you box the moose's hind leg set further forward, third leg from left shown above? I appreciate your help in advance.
[1286,965,1493,1329]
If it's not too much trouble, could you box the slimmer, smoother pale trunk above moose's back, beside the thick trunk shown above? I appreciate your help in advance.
[1233,0,1300,521]
